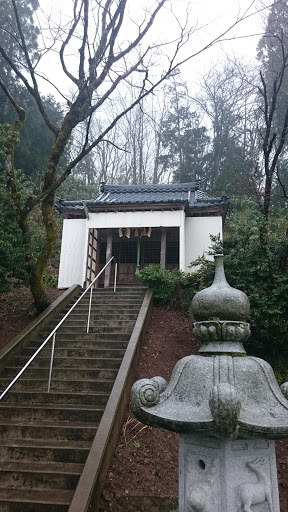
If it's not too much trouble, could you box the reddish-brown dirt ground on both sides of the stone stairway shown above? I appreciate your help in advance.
[0,288,288,512]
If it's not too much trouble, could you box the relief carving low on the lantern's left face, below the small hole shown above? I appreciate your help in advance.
[186,459,217,512]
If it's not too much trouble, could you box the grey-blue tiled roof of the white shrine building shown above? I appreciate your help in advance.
[56,182,229,217]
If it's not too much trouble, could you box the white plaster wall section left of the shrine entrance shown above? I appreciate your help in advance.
[58,219,88,288]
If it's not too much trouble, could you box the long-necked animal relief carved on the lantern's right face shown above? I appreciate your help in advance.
[238,458,273,512]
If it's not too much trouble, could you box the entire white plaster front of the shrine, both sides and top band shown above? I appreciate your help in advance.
[58,210,222,288]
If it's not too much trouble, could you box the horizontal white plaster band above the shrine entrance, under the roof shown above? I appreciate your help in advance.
[87,210,184,229]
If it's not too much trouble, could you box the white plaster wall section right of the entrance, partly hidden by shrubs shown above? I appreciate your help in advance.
[185,217,222,272]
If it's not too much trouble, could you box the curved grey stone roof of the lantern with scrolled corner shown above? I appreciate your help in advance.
[132,355,288,439]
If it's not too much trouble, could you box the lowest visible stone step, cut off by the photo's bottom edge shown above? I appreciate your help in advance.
[0,488,74,512]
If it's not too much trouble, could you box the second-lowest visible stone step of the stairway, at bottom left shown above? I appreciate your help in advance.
[0,461,83,490]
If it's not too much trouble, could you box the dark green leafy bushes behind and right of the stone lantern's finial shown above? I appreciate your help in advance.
[189,199,288,361]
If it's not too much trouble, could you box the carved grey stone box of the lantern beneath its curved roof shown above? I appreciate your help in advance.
[179,434,280,512]
